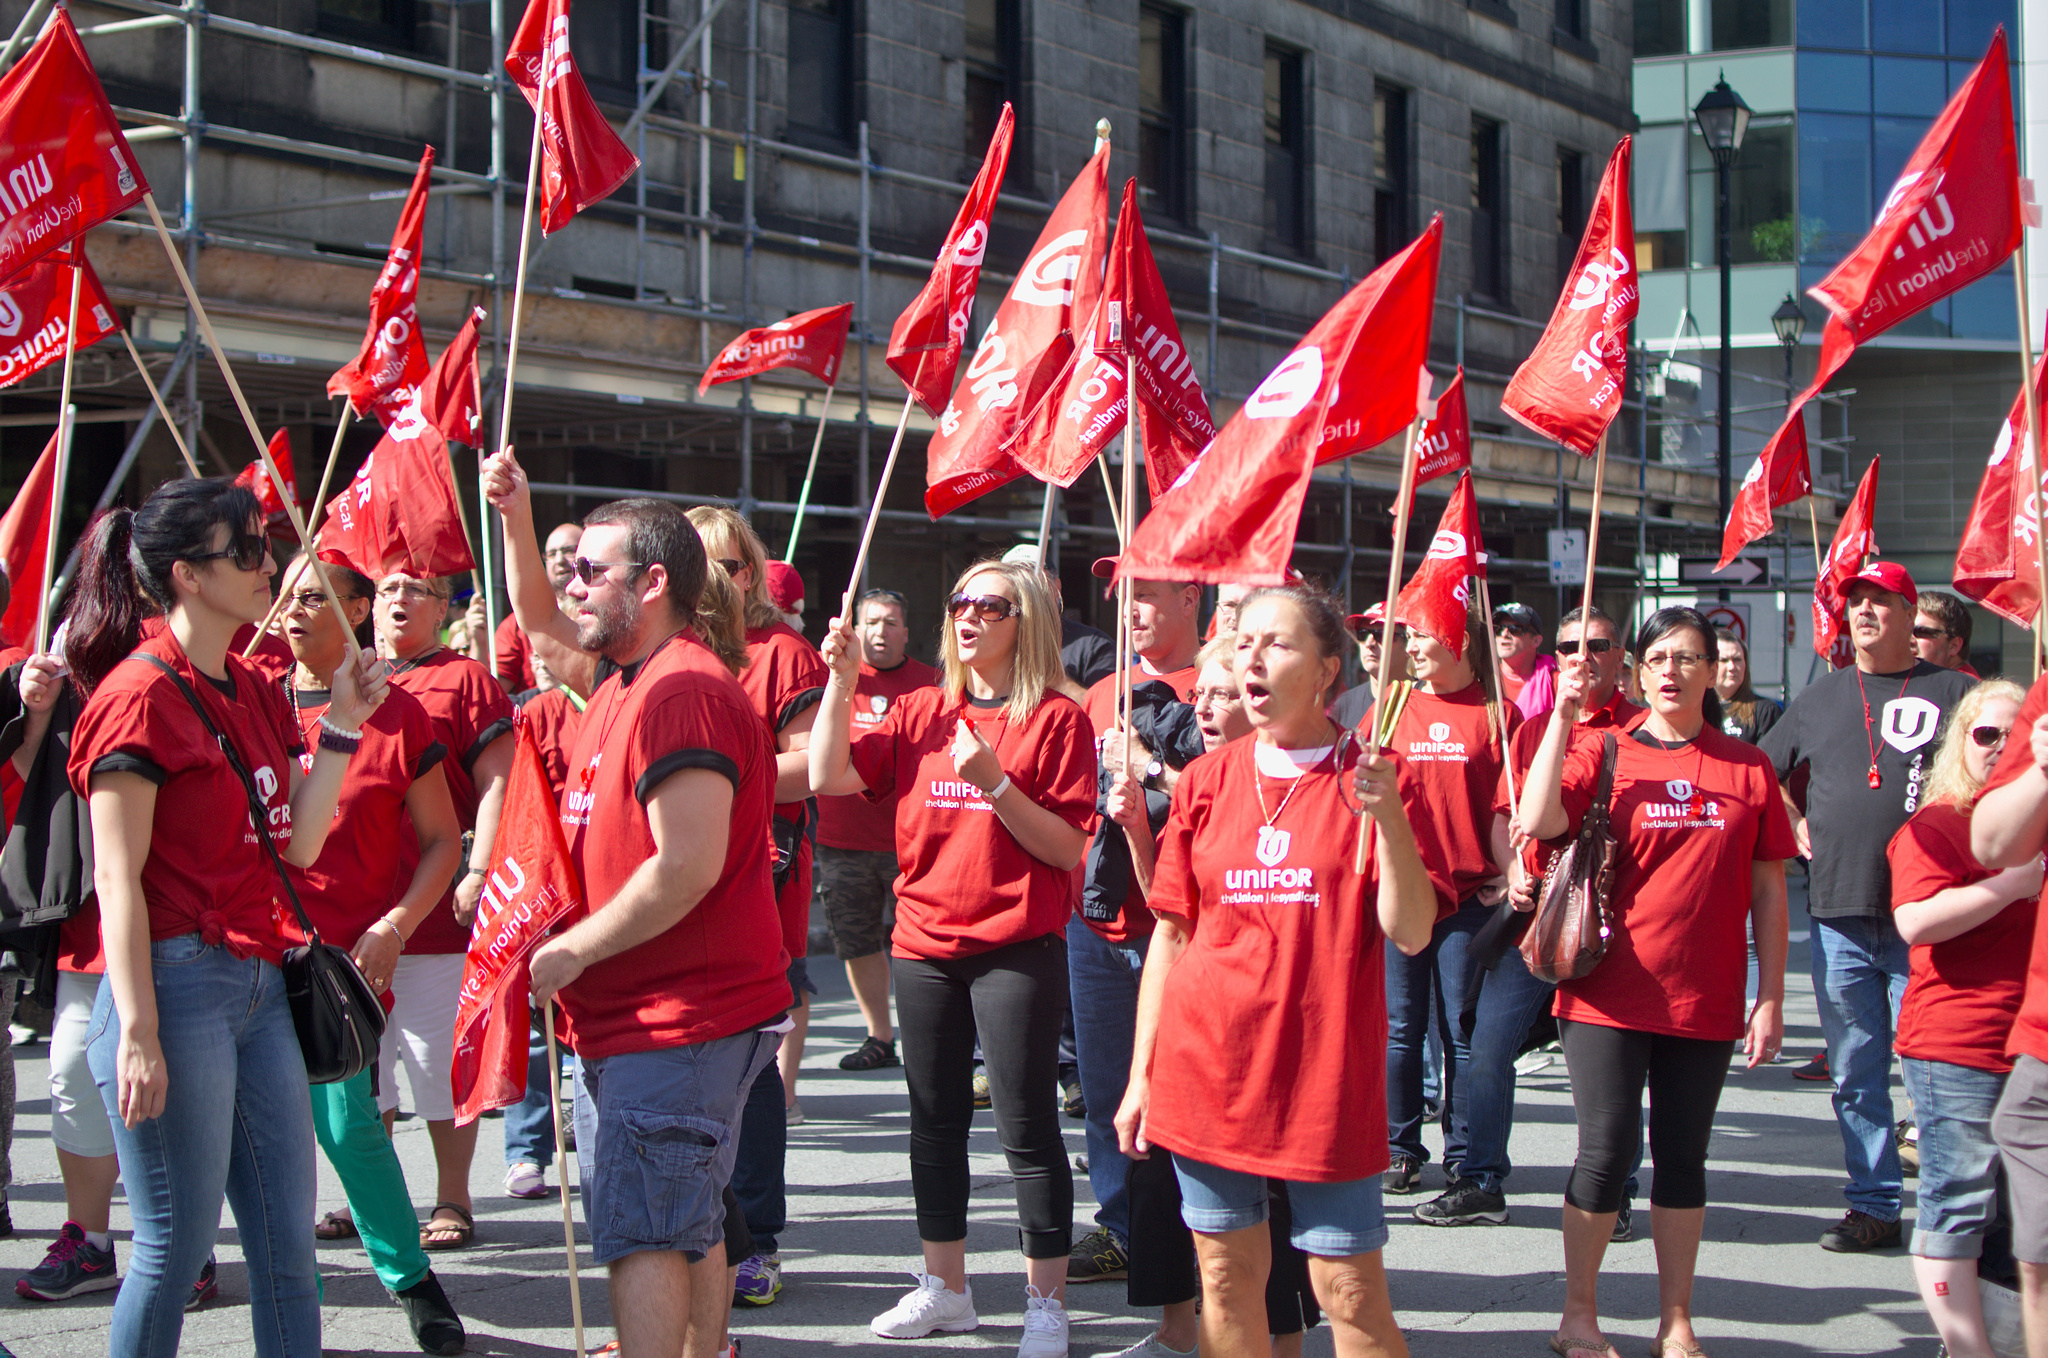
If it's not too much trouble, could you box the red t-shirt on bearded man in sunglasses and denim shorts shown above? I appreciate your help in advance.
[561,633,791,1057]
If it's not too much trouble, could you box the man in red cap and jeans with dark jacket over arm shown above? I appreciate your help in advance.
[1067,557,1202,1282]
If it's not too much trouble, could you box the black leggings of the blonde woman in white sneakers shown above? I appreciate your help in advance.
[895,934,1073,1260]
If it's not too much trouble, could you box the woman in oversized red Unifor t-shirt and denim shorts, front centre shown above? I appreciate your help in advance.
[1116,586,1436,1354]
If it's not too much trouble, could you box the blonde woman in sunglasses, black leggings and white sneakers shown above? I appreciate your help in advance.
[811,561,1096,1358]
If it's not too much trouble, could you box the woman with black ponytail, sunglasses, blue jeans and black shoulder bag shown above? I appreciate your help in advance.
[63,481,385,1358]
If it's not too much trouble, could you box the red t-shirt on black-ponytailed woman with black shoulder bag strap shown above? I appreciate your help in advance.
[68,631,299,963]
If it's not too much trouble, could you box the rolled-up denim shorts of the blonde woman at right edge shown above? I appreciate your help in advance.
[1898,1057,2005,1260]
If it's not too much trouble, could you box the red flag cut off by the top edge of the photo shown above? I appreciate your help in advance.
[506,0,639,236]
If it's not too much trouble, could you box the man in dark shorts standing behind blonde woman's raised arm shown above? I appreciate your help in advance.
[817,590,938,1071]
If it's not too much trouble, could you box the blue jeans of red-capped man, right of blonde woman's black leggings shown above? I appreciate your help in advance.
[1067,916,1151,1249]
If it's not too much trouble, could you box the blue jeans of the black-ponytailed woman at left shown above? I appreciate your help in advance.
[86,934,319,1358]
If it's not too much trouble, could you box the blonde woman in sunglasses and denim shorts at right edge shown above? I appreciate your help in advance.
[1884,680,2042,1354]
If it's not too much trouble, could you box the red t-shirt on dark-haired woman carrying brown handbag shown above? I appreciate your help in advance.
[1556,727,1798,1043]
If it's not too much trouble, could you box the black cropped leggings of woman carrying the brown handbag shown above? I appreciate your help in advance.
[1556,1018,1735,1213]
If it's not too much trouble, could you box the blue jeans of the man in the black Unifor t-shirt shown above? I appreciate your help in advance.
[1810,916,1909,1221]
